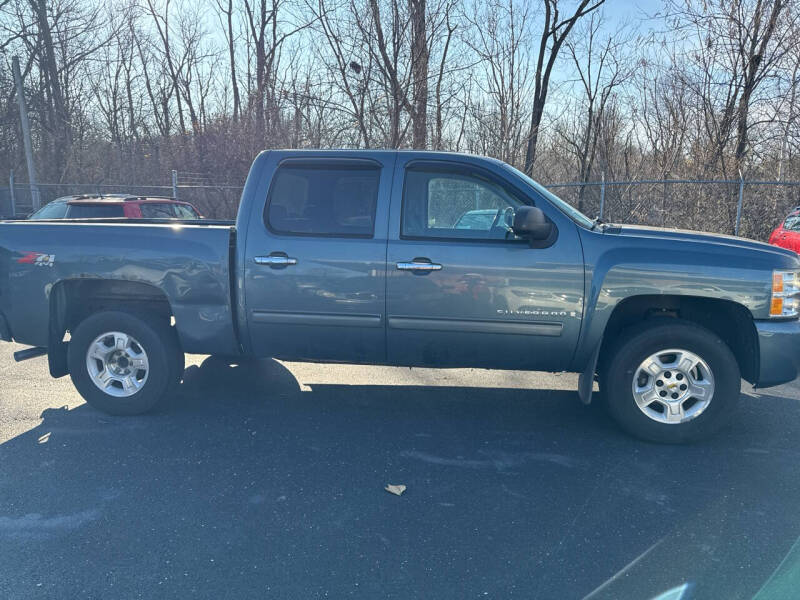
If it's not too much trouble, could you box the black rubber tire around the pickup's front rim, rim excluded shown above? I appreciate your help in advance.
[600,319,742,444]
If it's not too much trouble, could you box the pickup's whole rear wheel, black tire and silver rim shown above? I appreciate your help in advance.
[67,311,183,415]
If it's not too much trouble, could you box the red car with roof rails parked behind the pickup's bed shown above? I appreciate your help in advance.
[28,196,202,221]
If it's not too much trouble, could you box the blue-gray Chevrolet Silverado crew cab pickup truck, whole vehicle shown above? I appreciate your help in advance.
[0,150,800,442]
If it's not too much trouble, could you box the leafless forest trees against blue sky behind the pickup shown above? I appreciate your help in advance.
[0,0,800,235]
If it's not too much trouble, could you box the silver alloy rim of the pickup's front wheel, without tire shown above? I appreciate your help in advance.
[633,348,714,425]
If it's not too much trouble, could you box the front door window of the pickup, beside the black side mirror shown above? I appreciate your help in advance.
[402,169,524,240]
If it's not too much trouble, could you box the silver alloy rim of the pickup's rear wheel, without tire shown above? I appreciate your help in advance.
[86,331,150,398]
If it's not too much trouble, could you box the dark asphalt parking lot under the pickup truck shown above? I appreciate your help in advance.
[0,344,800,599]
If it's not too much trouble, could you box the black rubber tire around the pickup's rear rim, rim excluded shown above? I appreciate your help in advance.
[67,311,184,415]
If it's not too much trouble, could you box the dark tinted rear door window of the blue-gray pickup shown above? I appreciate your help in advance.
[266,162,380,237]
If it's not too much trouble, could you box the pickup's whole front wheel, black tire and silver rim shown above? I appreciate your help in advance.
[600,319,741,443]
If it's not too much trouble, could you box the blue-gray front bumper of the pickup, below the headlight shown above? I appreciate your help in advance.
[756,321,800,388]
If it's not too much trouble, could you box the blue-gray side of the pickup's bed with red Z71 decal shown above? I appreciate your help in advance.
[0,219,239,353]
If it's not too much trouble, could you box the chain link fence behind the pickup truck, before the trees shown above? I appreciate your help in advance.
[0,172,800,240]
